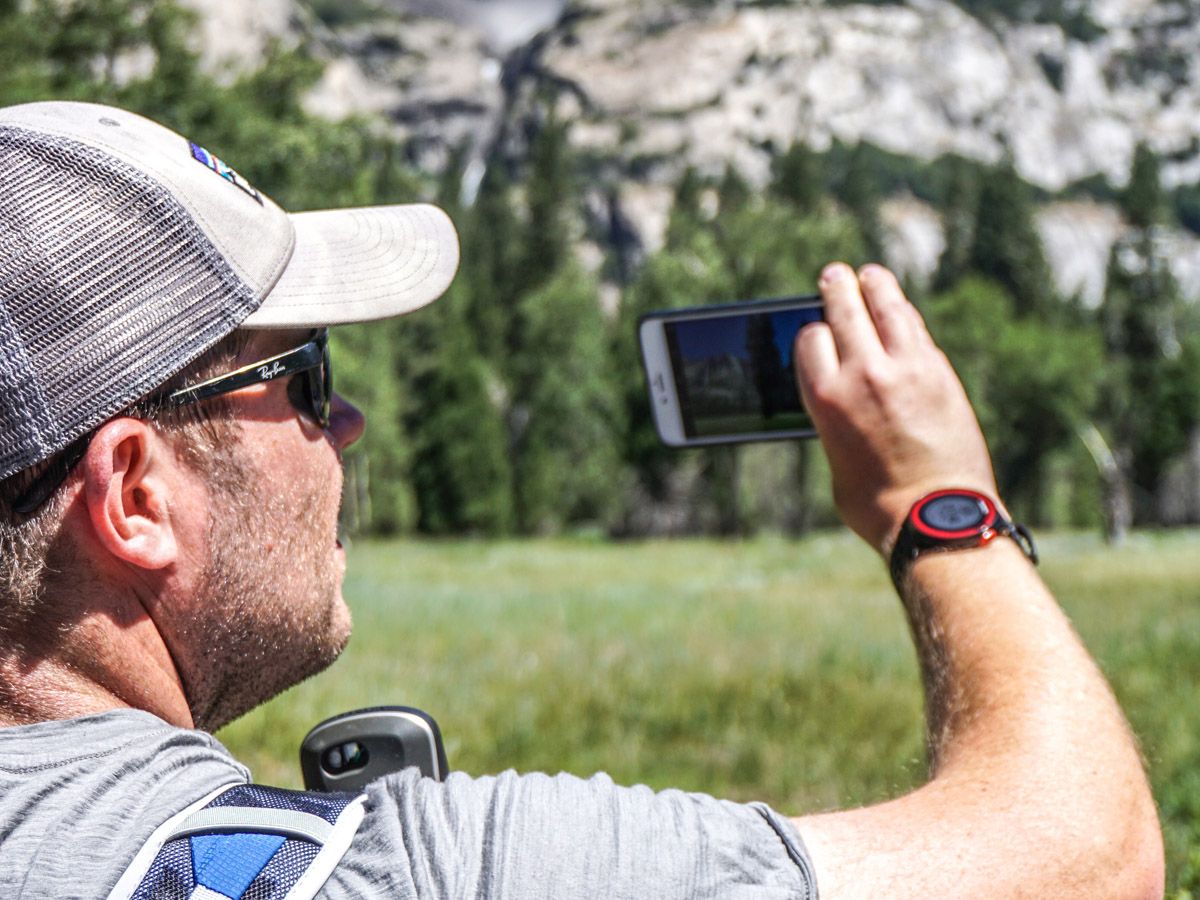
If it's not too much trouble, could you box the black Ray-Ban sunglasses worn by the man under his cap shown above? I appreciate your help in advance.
[12,329,334,516]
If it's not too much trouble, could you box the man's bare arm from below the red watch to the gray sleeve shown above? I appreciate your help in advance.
[800,540,1162,898]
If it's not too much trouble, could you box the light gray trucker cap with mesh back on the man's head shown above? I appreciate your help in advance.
[0,102,458,478]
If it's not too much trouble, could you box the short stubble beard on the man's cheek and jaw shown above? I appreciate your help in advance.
[185,444,350,731]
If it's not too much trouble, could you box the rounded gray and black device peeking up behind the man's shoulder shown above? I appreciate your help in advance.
[300,707,450,791]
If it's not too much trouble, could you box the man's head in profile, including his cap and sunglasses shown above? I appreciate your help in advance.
[0,103,457,727]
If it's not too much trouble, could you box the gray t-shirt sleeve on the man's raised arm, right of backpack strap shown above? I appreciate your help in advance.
[322,770,817,900]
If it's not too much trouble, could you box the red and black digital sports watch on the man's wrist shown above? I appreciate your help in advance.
[890,487,1038,588]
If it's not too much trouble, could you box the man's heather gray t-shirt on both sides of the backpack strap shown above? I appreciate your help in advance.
[0,709,816,900]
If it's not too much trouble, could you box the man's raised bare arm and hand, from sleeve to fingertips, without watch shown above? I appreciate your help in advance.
[794,264,1163,900]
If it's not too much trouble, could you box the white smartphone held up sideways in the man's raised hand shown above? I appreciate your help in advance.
[637,295,823,446]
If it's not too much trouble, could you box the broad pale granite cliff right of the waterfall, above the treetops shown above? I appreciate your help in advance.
[540,0,1200,190]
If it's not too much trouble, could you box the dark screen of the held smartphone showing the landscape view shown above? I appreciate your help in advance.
[662,306,822,438]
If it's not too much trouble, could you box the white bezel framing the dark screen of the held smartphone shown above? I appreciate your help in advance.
[638,296,821,448]
